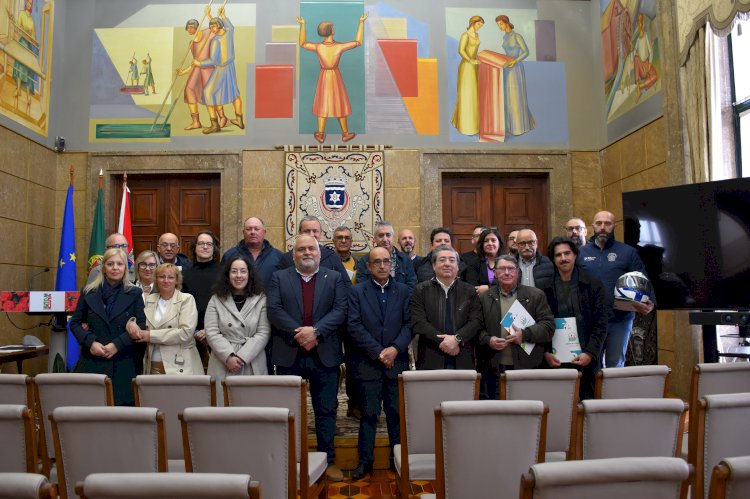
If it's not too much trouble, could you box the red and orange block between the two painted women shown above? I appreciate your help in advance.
[477,50,513,142]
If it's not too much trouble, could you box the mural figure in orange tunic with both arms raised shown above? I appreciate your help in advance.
[297,12,367,144]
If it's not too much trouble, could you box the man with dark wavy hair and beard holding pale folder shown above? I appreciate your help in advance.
[544,236,607,400]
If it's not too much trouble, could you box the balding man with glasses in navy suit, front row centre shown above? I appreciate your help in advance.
[349,247,411,480]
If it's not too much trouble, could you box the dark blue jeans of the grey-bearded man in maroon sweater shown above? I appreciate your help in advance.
[276,352,339,464]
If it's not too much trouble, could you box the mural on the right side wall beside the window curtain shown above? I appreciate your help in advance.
[600,0,661,123]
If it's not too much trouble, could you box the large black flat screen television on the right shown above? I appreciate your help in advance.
[622,178,750,310]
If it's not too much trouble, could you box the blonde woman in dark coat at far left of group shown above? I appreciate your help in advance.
[70,248,146,405]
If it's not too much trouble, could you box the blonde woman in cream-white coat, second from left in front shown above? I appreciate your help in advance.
[134,263,204,374]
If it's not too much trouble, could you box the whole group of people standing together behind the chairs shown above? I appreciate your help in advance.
[70,212,649,480]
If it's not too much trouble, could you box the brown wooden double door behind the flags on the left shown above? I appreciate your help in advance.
[112,174,221,257]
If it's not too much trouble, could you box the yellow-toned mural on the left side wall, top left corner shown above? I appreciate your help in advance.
[0,0,55,137]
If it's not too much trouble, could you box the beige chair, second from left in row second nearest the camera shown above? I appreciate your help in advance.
[50,407,167,499]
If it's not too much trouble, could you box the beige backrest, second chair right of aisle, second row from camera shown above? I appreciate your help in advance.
[576,398,687,459]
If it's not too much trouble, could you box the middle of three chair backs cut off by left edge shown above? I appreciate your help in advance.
[0,405,36,473]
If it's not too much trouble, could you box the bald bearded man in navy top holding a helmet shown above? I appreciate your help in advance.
[578,211,654,367]
